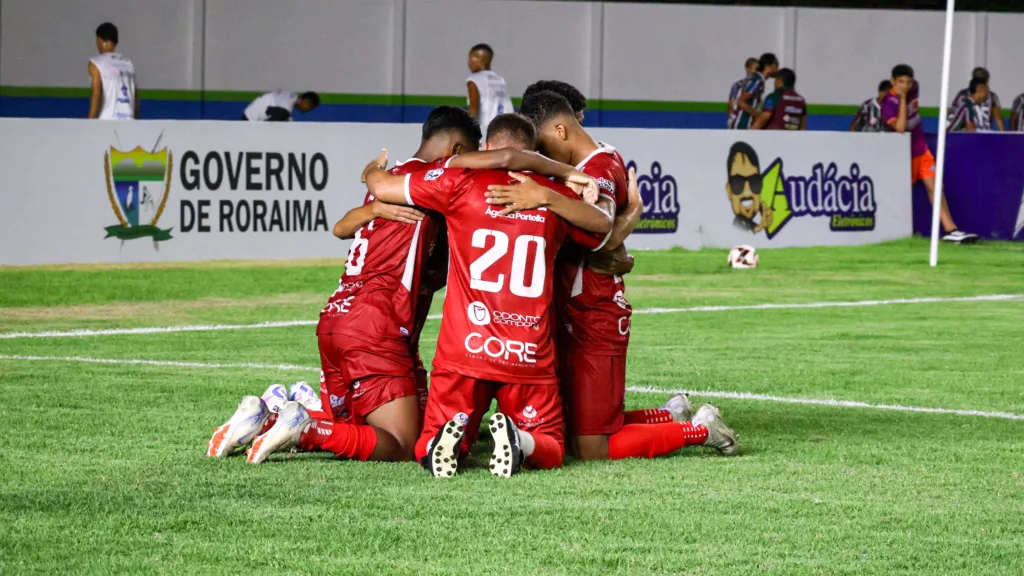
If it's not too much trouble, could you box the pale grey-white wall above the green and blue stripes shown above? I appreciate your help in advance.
[0,0,1024,106]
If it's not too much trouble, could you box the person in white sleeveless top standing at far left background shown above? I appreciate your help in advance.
[89,22,138,120]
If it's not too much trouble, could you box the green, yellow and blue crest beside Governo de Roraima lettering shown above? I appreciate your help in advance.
[103,133,174,248]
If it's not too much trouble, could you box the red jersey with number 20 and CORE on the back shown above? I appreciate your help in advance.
[406,168,604,384]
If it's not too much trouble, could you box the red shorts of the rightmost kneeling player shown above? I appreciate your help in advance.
[559,354,626,437]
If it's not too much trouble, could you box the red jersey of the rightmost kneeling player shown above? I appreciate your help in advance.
[555,143,633,356]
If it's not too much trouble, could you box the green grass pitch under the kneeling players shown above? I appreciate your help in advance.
[0,240,1024,575]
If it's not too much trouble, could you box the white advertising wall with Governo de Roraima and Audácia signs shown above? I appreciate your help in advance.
[0,119,911,264]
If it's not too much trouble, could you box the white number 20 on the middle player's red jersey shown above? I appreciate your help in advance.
[469,229,548,298]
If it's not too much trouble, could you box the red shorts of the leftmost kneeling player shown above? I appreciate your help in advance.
[317,334,419,424]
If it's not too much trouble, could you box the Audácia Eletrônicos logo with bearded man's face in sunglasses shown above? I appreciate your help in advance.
[725,141,876,240]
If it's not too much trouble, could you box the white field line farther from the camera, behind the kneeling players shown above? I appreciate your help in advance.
[0,294,1024,340]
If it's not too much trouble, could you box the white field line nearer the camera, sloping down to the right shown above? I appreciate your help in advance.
[0,355,1024,420]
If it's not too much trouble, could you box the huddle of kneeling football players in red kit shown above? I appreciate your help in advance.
[207,82,738,477]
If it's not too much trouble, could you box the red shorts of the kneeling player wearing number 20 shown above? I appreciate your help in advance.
[416,370,565,459]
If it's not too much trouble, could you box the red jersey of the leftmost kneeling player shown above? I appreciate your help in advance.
[316,159,444,348]
